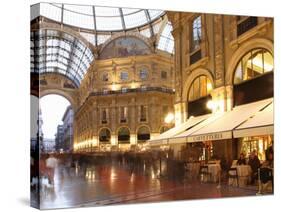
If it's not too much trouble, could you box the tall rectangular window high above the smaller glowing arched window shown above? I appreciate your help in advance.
[190,16,202,52]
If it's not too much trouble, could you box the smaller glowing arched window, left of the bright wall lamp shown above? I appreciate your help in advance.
[188,75,213,102]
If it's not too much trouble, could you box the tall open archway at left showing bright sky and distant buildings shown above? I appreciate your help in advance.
[39,94,74,153]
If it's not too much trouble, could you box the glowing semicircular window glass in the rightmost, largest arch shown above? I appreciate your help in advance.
[234,49,274,84]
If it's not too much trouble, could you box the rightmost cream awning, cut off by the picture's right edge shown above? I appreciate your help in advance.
[233,103,274,138]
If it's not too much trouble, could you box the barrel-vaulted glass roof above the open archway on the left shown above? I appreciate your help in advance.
[30,29,94,87]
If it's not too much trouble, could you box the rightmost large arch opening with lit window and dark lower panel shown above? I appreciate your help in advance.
[233,48,274,106]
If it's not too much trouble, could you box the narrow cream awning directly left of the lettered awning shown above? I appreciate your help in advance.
[148,114,211,146]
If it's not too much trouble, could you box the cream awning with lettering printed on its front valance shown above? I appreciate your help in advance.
[187,98,273,142]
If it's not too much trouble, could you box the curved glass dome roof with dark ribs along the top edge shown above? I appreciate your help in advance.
[31,3,164,31]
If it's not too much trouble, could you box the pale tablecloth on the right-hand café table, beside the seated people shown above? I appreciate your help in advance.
[228,165,252,186]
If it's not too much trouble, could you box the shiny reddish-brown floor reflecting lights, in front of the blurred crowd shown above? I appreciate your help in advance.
[36,164,256,209]
